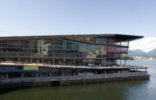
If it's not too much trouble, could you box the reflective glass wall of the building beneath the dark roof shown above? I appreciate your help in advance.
[0,37,128,65]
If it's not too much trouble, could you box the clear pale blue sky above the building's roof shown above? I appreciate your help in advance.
[0,0,156,51]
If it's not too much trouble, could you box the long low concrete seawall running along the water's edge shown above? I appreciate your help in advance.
[0,72,150,93]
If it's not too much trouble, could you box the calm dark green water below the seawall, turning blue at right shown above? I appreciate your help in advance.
[0,60,156,100]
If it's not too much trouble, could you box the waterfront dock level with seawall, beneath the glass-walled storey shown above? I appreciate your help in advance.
[0,64,150,93]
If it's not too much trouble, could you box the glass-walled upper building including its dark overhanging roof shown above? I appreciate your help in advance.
[0,34,142,66]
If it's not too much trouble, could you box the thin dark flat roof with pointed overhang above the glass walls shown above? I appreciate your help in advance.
[0,34,143,41]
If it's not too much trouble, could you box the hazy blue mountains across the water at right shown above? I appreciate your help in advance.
[128,49,156,57]
